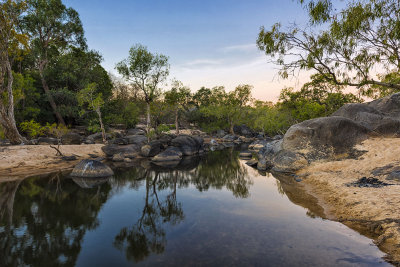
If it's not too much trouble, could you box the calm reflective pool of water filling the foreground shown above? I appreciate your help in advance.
[0,150,388,266]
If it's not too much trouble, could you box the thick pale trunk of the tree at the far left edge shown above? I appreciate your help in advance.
[0,58,26,145]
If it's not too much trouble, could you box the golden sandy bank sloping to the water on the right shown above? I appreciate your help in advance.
[297,138,400,265]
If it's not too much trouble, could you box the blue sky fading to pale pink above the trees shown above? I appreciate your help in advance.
[63,0,308,101]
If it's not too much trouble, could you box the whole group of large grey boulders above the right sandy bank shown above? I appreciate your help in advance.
[249,93,400,172]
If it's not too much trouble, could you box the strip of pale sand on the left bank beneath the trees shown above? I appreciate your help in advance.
[0,144,104,181]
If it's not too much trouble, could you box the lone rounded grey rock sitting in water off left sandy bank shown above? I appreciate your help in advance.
[71,159,114,178]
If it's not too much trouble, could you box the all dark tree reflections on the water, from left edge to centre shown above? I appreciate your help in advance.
[0,149,251,266]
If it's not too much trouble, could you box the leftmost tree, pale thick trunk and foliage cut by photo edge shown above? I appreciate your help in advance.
[0,0,28,144]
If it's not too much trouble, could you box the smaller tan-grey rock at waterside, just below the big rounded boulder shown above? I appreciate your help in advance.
[272,150,308,172]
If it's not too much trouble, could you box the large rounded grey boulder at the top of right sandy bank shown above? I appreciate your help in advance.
[282,116,371,159]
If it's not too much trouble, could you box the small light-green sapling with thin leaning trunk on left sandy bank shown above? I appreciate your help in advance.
[78,83,106,143]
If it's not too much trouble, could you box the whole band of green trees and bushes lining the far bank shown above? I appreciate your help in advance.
[0,0,400,144]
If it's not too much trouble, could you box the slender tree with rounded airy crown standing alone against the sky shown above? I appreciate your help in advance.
[116,44,169,135]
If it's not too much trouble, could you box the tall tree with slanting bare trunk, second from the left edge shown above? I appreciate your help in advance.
[24,0,86,125]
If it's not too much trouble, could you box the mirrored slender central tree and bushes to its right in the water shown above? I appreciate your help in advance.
[114,149,251,262]
